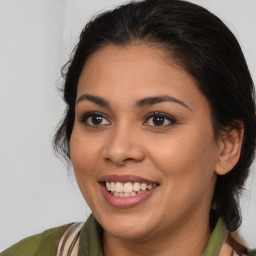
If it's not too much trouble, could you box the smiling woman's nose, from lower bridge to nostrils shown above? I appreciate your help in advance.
[103,124,145,166]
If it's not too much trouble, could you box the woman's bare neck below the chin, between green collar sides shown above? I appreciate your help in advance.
[103,215,211,256]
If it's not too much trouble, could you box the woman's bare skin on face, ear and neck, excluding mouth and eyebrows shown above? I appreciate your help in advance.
[70,43,243,256]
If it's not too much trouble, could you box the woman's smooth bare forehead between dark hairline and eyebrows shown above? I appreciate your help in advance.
[77,44,208,112]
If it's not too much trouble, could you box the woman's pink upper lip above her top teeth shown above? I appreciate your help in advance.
[98,174,158,184]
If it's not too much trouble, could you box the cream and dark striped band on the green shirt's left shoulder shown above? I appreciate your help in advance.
[57,222,84,256]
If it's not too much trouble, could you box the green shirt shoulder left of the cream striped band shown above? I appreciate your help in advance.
[0,223,72,256]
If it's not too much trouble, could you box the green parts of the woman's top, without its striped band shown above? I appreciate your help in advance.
[0,215,231,256]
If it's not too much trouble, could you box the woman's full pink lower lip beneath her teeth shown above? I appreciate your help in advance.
[100,183,158,208]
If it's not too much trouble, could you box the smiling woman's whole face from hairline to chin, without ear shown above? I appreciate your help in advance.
[70,44,219,242]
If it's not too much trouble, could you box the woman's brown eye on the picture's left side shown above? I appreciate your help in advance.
[79,112,111,127]
